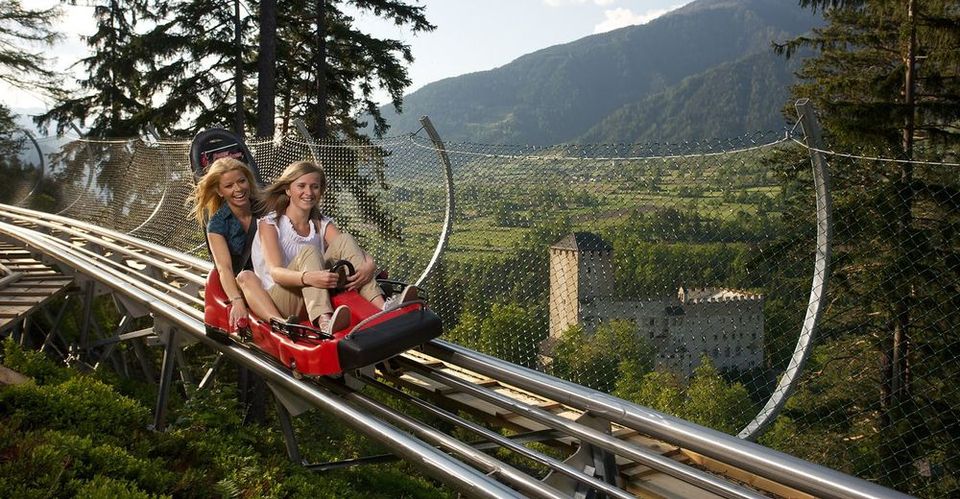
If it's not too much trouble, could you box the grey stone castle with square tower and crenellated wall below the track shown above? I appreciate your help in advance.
[544,232,764,376]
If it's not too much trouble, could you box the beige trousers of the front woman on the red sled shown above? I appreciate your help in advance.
[267,232,381,321]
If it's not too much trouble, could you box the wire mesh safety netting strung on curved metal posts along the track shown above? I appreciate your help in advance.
[4,123,960,497]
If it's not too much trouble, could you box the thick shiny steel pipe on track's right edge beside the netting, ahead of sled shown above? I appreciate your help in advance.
[423,340,910,499]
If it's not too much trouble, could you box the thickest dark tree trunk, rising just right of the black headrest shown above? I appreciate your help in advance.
[257,0,277,137]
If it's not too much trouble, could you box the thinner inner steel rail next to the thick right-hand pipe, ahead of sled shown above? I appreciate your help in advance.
[400,359,767,499]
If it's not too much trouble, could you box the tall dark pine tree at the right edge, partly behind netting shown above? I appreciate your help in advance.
[778,0,960,488]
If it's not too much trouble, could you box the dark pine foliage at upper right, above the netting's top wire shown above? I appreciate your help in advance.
[780,0,960,152]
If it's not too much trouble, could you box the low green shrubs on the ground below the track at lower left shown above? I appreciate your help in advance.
[0,358,454,498]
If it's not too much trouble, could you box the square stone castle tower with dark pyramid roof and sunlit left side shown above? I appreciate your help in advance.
[550,232,614,338]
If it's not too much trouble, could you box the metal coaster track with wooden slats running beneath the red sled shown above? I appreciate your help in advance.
[0,205,899,498]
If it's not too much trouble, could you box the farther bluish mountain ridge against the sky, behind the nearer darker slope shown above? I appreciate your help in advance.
[372,0,817,145]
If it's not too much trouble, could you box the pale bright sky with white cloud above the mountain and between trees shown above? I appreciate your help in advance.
[0,0,690,128]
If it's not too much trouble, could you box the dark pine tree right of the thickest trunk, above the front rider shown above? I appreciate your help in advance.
[277,0,434,139]
